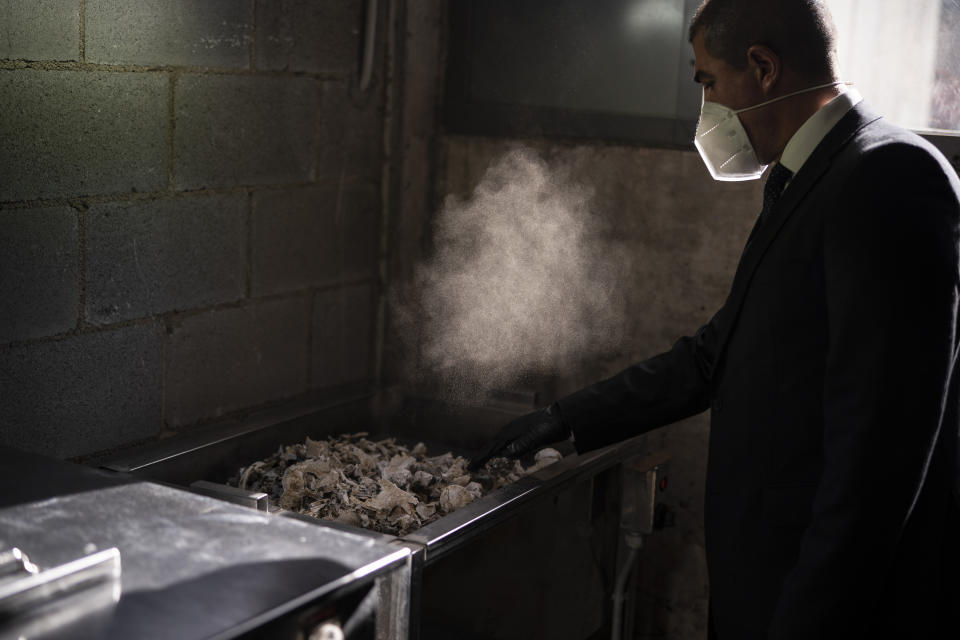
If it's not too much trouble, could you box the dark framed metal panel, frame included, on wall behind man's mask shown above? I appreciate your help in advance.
[446,0,700,147]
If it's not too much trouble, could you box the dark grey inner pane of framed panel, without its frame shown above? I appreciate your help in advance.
[467,0,684,118]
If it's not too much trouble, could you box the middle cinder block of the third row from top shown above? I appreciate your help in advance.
[84,194,246,324]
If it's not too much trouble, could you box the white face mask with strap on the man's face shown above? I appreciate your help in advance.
[693,82,843,182]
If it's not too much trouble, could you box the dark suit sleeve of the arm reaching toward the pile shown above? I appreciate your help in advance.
[558,310,723,453]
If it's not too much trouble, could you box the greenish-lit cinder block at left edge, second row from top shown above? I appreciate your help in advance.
[0,69,168,201]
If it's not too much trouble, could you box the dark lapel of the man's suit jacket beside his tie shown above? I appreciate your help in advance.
[714,102,880,370]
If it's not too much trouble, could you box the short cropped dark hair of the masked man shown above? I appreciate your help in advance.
[689,0,837,81]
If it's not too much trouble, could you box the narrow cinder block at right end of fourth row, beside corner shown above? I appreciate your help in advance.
[311,284,377,388]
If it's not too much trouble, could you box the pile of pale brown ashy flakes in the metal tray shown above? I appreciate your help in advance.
[228,433,561,536]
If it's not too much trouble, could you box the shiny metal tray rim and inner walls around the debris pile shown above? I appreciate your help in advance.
[97,394,642,563]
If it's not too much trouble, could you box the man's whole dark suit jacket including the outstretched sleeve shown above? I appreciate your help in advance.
[559,103,960,640]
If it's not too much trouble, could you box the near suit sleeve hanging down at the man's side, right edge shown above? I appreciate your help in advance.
[770,144,960,640]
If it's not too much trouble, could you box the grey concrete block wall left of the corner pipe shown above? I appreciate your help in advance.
[0,0,389,457]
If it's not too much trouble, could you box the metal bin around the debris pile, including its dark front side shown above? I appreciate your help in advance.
[97,391,665,640]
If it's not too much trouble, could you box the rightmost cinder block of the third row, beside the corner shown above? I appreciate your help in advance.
[251,187,379,295]
